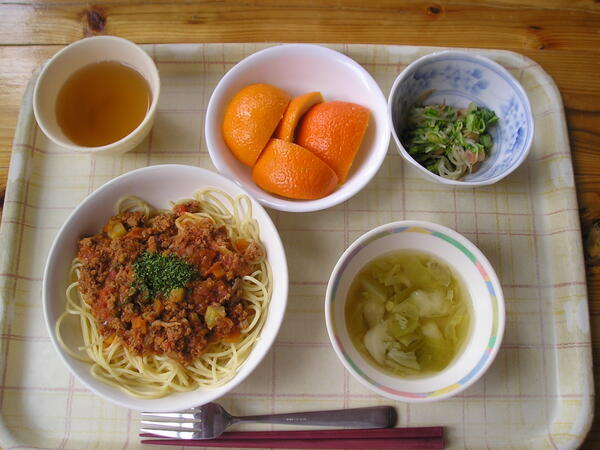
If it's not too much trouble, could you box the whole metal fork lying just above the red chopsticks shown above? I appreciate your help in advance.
[141,403,397,439]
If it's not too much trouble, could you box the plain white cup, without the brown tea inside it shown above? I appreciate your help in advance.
[33,36,160,154]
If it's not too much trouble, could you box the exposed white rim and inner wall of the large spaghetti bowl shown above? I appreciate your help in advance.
[42,164,288,412]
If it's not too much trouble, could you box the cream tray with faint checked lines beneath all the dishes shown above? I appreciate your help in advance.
[0,44,593,449]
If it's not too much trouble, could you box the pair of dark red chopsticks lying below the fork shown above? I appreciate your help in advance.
[140,427,444,449]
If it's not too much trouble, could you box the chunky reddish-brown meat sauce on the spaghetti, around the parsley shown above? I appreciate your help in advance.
[77,201,262,365]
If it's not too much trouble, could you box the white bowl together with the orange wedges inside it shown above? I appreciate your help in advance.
[205,44,390,212]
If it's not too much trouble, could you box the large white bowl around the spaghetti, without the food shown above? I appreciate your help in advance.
[42,165,288,411]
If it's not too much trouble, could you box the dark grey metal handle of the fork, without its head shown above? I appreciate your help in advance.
[232,406,397,428]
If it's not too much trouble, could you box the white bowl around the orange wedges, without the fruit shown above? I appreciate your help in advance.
[205,44,390,212]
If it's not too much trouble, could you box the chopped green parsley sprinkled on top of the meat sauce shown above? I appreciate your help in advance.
[133,252,198,297]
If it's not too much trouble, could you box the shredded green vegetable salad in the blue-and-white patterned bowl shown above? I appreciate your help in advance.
[401,103,498,180]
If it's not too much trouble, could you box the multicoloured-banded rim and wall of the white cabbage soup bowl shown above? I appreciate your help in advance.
[325,220,505,403]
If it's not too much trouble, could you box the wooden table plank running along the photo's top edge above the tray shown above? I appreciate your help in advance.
[0,0,600,50]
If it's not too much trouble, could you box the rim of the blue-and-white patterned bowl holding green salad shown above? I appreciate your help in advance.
[387,50,535,188]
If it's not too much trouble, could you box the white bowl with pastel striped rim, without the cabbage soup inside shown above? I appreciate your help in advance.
[325,220,505,402]
